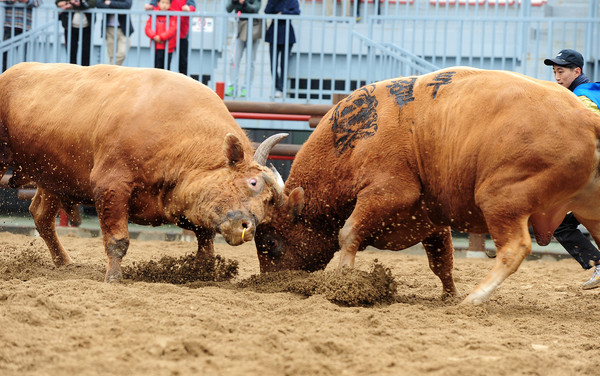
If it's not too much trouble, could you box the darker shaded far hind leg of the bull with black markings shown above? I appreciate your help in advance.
[422,227,458,299]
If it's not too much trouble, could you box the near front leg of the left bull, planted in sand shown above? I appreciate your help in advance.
[92,177,131,283]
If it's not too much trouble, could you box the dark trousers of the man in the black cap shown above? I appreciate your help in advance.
[554,213,600,269]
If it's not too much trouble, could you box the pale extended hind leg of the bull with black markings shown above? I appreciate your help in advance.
[462,218,531,304]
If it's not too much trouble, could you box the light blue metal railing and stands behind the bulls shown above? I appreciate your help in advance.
[0,0,600,106]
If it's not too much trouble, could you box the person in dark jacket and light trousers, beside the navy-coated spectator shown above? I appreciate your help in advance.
[225,0,262,97]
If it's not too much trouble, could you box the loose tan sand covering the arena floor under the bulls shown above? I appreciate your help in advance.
[0,233,600,376]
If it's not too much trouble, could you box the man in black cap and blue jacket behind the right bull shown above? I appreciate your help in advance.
[544,49,600,290]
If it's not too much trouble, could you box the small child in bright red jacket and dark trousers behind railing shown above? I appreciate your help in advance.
[146,0,177,70]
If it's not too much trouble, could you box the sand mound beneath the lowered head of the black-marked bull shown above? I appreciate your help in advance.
[239,260,398,306]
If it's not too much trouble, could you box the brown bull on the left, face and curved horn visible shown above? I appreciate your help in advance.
[0,63,285,282]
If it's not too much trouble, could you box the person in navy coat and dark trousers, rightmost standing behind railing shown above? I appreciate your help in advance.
[265,0,300,98]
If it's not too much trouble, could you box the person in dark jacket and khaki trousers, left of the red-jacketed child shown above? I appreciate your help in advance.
[96,0,133,65]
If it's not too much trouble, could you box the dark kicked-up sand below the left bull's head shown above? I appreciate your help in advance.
[123,254,238,284]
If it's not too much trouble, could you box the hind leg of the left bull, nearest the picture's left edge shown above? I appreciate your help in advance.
[29,187,73,266]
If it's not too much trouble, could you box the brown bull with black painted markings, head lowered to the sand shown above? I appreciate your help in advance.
[255,67,600,304]
